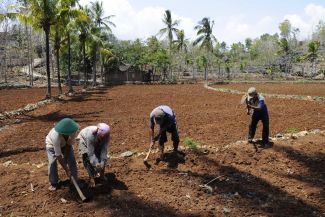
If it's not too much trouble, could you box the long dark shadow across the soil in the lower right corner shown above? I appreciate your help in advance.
[163,152,323,216]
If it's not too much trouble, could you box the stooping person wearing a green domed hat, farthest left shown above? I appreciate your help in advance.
[45,118,79,191]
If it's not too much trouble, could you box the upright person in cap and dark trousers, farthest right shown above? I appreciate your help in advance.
[246,87,269,146]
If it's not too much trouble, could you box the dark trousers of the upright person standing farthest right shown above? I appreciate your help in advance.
[248,113,269,143]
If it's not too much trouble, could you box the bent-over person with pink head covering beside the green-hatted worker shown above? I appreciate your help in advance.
[77,123,110,187]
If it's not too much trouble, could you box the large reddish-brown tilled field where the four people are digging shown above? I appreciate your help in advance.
[0,85,325,216]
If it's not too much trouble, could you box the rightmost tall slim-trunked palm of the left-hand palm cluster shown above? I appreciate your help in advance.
[90,0,115,86]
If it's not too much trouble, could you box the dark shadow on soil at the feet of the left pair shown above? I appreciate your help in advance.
[60,173,198,217]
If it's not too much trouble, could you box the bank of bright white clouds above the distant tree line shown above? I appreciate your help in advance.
[80,0,325,44]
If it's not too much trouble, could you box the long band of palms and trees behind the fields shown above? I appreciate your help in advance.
[0,0,325,97]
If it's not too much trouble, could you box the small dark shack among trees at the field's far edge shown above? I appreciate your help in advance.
[105,64,145,84]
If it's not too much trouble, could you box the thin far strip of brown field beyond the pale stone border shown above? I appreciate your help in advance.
[214,83,325,96]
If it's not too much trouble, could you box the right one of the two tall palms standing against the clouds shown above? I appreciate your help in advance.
[193,17,217,80]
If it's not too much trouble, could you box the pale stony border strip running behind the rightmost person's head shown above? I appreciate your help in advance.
[204,84,325,102]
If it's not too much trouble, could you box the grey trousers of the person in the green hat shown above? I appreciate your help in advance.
[46,145,77,186]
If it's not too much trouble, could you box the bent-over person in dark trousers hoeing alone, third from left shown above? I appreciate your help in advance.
[149,105,179,160]
